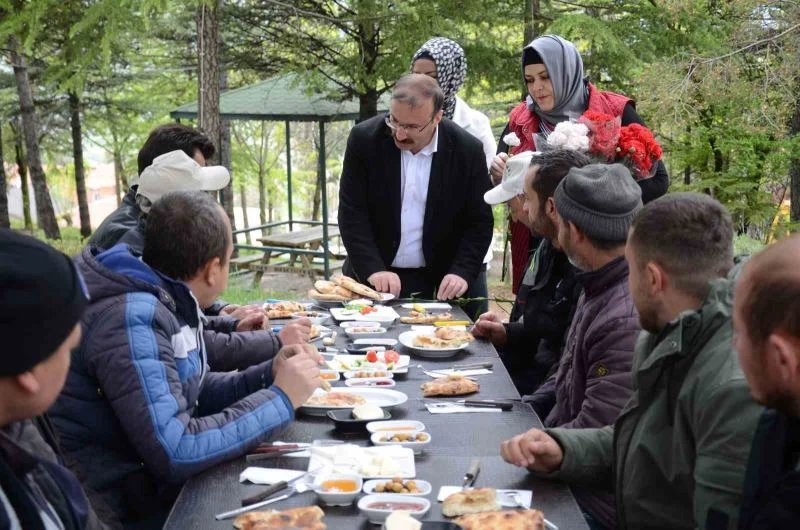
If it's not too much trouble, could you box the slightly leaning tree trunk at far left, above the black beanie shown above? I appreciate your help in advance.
[8,36,61,239]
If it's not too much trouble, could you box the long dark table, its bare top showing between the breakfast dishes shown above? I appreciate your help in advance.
[164,304,588,530]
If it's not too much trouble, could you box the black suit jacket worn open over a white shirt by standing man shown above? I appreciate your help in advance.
[339,115,493,290]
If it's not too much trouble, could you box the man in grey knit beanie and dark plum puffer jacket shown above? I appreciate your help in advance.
[502,164,642,528]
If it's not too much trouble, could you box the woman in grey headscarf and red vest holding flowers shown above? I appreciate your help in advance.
[490,35,669,293]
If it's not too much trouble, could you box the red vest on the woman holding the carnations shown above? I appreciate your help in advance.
[508,83,631,294]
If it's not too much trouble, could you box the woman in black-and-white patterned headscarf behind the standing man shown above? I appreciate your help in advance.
[411,37,497,318]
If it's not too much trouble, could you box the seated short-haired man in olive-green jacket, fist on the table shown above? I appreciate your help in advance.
[501,193,772,530]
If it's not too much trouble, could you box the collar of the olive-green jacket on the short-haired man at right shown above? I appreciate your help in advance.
[637,279,733,370]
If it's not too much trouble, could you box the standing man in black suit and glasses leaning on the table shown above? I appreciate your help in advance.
[339,74,493,300]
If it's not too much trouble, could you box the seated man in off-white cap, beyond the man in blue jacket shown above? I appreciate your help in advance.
[120,151,311,372]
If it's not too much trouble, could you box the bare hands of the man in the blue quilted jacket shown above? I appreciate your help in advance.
[272,344,322,408]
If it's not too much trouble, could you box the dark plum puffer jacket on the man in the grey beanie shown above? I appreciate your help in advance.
[533,257,641,528]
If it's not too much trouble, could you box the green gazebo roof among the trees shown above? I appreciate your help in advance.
[170,73,389,122]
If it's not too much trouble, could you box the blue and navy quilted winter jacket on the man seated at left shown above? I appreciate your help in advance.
[50,245,294,521]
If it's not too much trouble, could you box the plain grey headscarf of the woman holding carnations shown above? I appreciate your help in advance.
[522,35,589,125]
